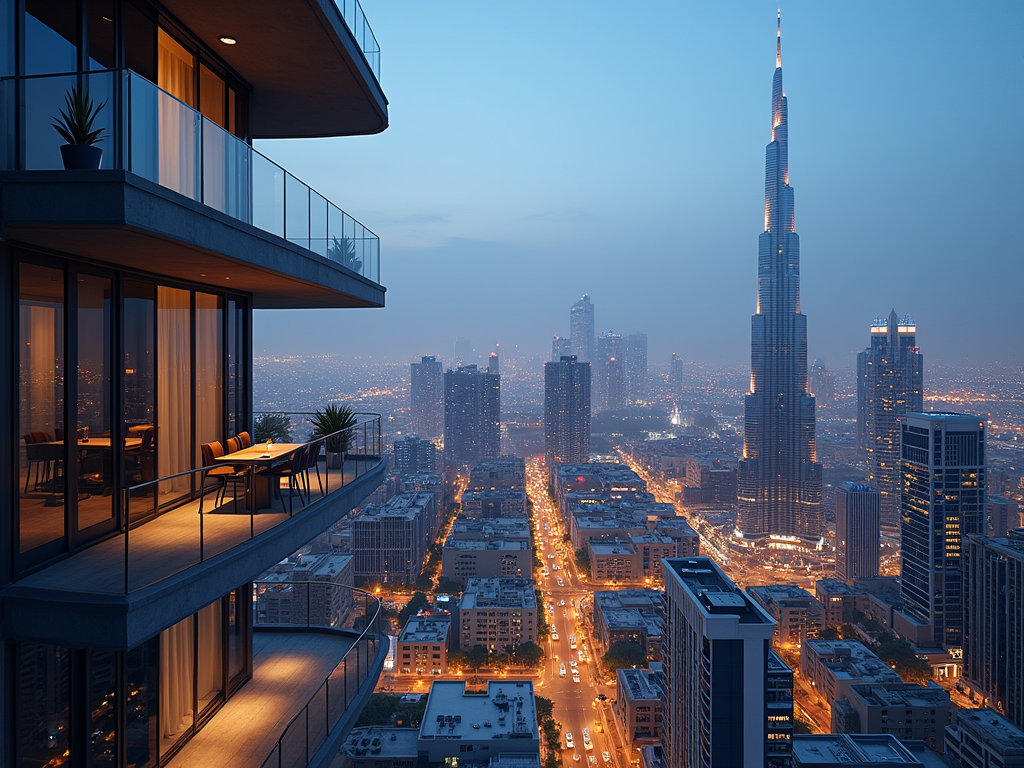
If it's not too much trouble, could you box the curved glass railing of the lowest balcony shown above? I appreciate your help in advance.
[253,581,385,768]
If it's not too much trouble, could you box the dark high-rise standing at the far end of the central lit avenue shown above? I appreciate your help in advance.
[544,355,590,466]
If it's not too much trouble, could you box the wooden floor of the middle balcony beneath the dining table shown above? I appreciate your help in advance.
[18,463,362,595]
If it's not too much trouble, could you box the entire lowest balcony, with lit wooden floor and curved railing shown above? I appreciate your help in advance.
[168,582,387,768]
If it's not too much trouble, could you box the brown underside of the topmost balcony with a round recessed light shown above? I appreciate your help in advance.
[164,0,388,138]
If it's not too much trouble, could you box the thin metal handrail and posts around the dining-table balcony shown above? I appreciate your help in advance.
[116,414,382,595]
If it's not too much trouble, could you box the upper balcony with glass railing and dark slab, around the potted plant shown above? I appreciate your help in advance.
[0,70,384,308]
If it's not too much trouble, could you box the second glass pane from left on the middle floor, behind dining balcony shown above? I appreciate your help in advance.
[75,274,113,530]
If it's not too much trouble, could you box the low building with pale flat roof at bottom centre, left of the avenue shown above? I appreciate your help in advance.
[418,680,541,766]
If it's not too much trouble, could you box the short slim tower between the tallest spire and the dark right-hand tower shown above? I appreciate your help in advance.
[836,481,881,582]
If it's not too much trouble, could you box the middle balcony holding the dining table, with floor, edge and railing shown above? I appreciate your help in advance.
[3,414,387,649]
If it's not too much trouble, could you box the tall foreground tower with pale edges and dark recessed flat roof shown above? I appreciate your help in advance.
[663,557,775,768]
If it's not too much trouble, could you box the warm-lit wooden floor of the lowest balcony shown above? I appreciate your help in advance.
[168,632,352,768]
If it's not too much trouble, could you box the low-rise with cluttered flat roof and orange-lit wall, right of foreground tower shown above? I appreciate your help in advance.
[800,640,903,701]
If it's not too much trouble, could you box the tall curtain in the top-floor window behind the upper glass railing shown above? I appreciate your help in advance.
[157,30,199,200]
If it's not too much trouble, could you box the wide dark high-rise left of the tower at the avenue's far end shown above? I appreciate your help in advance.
[444,366,501,465]
